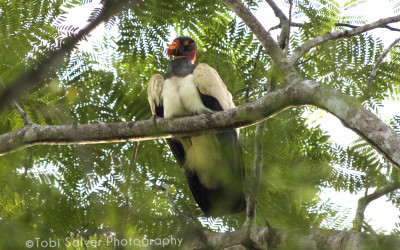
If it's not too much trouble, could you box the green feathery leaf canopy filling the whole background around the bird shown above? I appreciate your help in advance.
[0,0,400,249]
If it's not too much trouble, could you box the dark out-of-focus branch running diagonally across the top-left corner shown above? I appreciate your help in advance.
[0,0,135,110]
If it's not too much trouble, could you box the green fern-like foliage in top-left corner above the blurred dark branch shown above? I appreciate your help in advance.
[0,0,79,85]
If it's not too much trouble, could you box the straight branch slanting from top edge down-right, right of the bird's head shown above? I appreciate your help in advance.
[221,0,283,65]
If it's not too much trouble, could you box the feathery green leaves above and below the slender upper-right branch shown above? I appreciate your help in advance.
[290,0,400,111]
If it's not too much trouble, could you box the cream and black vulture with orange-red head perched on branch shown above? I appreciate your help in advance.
[147,36,246,217]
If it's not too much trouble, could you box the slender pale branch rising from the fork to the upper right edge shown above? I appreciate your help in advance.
[290,15,400,65]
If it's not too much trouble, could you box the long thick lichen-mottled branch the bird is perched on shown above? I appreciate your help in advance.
[0,77,400,171]
